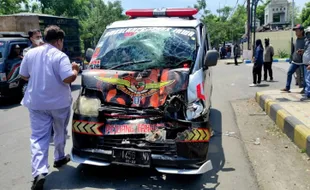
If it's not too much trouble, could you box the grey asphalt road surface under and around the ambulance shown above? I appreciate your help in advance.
[0,62,286,190]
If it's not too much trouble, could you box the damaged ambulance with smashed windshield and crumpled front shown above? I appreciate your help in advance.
[71,8,219,174]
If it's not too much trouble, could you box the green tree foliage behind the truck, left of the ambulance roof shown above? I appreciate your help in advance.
[0,0,127,49]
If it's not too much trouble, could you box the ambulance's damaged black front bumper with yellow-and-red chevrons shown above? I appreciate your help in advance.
[71,114,212,174]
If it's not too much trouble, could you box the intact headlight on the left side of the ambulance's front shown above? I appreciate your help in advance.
[73,96,101,117]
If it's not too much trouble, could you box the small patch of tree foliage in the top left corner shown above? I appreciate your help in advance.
[0,0,27,14]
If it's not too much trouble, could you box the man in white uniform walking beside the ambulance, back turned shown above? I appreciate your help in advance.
[20,26,79,190]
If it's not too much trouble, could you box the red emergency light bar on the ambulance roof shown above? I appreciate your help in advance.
[126,8,198,18]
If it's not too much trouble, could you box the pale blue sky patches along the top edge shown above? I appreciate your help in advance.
[115,0,309,13]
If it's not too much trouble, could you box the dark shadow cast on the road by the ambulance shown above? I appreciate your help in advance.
[45,109,228,190]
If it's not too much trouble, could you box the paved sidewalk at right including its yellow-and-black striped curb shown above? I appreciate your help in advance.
[256,89,310,156]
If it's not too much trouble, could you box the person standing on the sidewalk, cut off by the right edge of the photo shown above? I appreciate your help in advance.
[300,26,310,101]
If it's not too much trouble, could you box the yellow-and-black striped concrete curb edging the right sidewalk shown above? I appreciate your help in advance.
[255,92,310,156]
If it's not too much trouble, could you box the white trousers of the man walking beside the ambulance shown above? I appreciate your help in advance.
[29,107,71,177]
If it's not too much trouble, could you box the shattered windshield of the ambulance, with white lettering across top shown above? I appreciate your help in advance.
[91,27,196,70]
